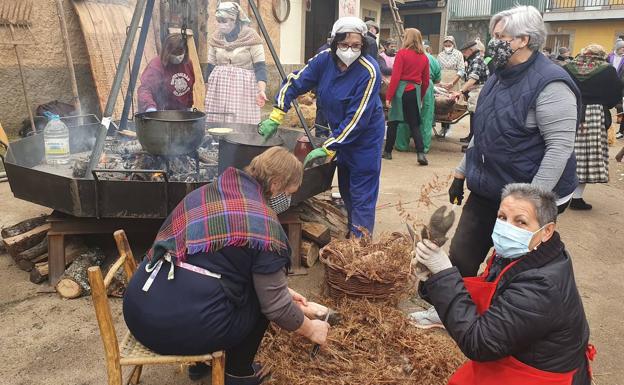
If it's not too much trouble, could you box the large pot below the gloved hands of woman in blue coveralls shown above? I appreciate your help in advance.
[219,132,284,174]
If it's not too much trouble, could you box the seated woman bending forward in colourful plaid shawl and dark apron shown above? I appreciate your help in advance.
[123,147,329,385]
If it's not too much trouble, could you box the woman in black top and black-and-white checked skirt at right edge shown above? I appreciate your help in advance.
[563,44,623,210]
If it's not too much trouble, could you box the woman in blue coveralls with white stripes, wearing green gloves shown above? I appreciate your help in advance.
[258,17,384,236]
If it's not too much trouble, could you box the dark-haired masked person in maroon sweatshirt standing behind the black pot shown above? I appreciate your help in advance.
[137,33,195,112]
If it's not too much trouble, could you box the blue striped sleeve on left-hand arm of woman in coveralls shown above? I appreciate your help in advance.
[275,49,330,112]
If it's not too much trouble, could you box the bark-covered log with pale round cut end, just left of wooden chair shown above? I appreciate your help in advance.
[56,248,105,299]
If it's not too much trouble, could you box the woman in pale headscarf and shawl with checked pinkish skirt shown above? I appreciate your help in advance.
[205,1,268,124]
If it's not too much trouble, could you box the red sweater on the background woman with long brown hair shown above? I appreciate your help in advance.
[386,49,429,101]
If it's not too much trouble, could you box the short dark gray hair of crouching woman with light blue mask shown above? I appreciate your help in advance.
[501,183,558,226]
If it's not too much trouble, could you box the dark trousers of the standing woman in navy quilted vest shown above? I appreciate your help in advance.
[449,193,569,277]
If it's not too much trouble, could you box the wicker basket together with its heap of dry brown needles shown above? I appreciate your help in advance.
[320,233,413,300]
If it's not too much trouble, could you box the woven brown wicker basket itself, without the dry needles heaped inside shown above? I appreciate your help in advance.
[319,243,407,300]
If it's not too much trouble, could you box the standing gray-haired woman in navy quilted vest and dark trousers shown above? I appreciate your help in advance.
[412,6,580,327]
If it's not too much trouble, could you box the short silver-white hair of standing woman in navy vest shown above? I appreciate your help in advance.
[490,5,546,51]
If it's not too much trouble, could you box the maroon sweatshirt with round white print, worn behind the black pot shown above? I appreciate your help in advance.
[137,57,195,112]
